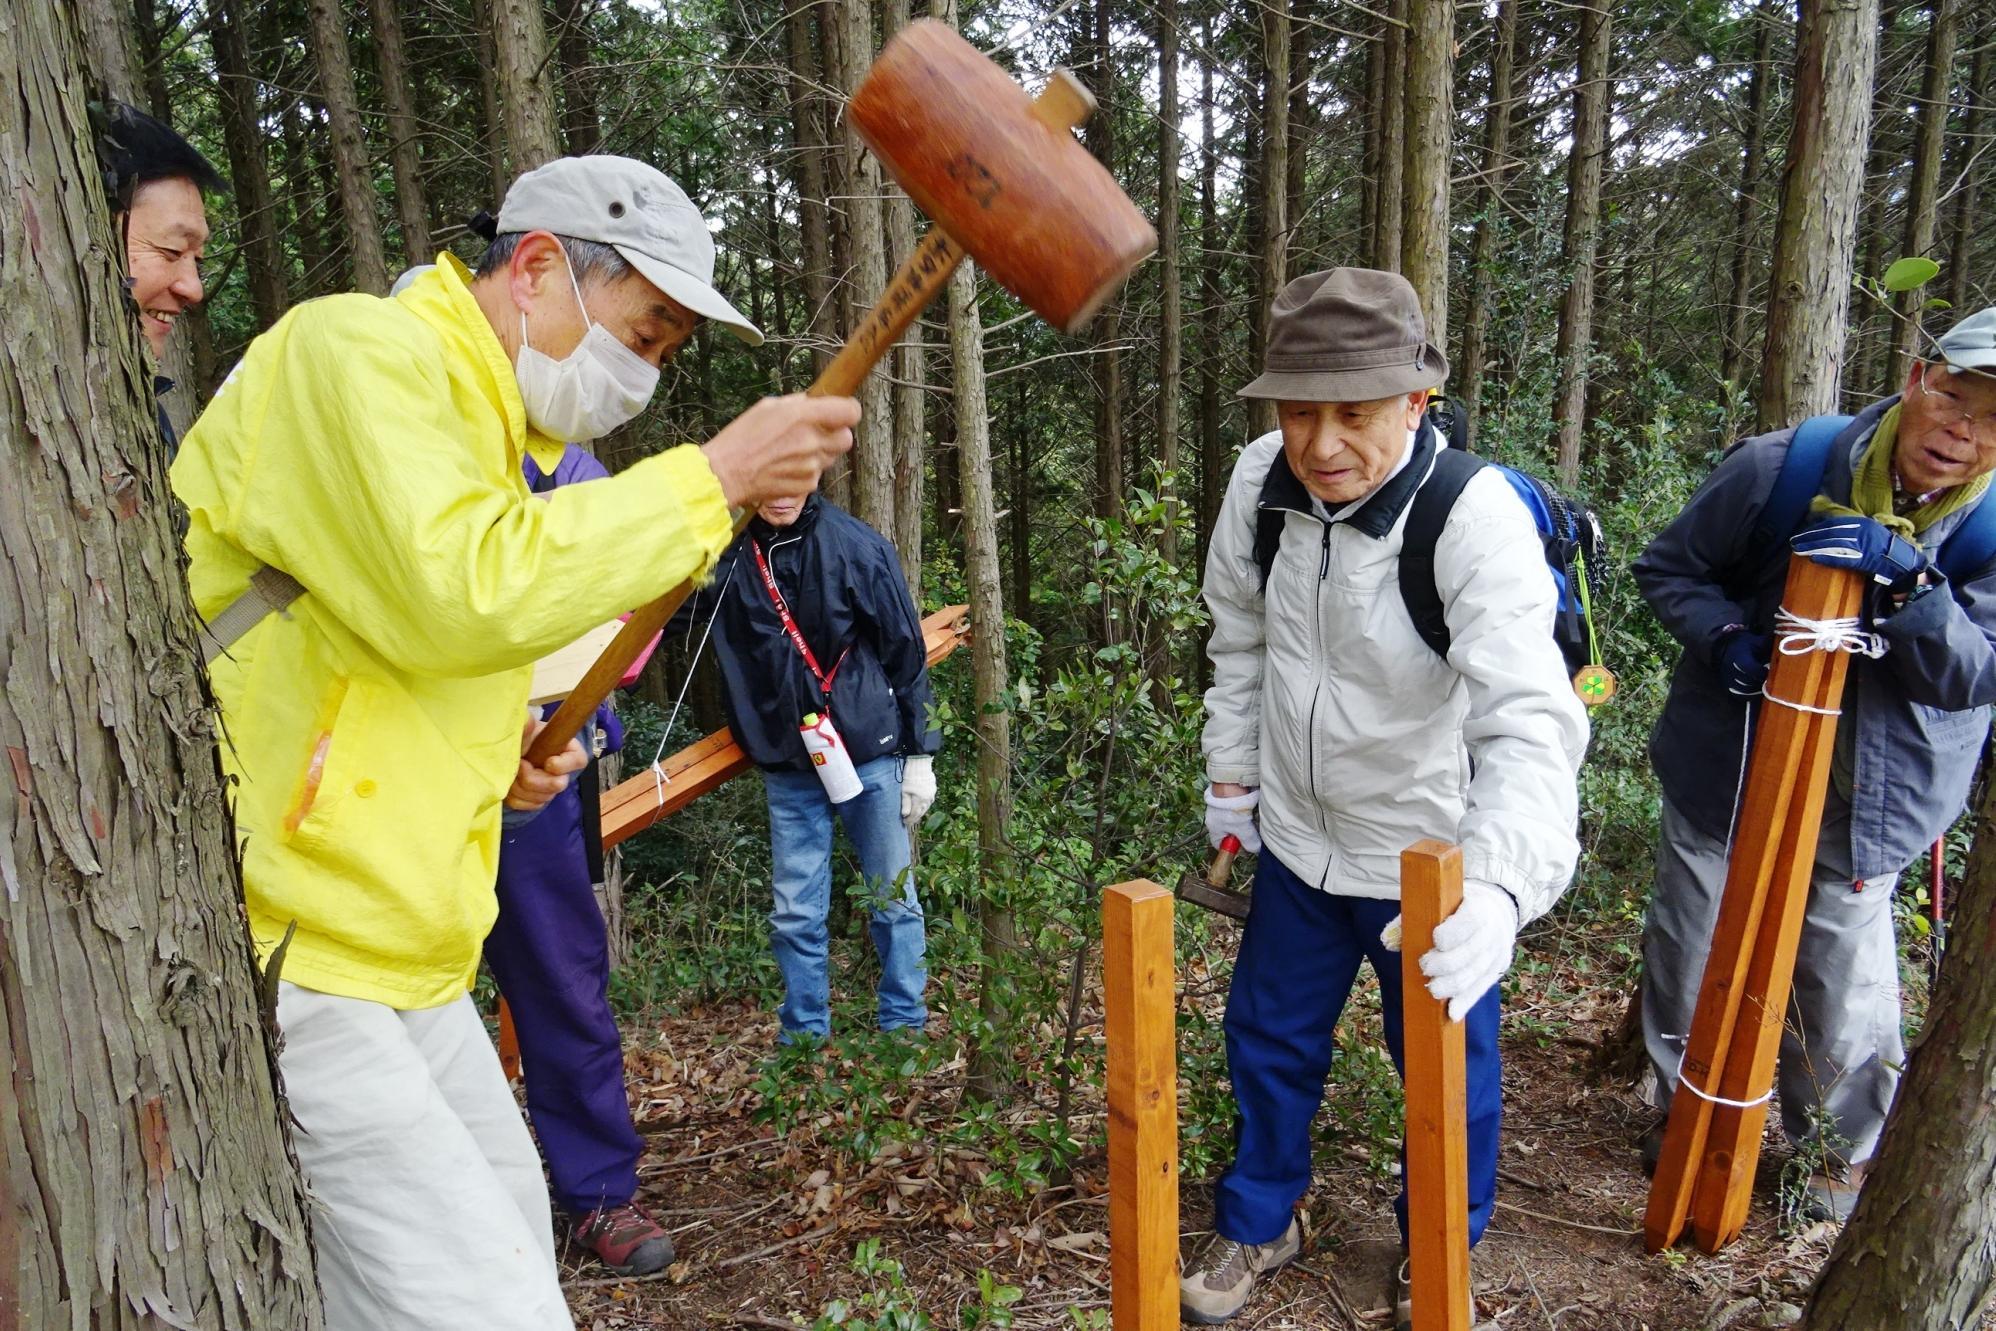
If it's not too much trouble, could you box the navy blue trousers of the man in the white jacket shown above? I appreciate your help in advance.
[1214,850,1503,1243]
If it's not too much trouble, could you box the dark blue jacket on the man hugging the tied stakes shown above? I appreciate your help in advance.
[1635,397,1996,878]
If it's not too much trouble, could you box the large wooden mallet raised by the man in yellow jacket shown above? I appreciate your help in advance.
[527,20,1158,766]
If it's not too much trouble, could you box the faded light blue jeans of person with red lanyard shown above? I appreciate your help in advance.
[762,756,928,1044]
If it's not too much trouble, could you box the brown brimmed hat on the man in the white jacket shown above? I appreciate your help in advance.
[1240,267,1449,401]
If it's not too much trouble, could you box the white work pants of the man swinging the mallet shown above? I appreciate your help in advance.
[277,984,575,1331]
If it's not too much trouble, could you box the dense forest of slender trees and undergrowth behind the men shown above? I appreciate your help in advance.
[19,0,1996,1325]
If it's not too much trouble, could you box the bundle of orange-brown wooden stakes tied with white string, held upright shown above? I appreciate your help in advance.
[1643,555,1864,1253]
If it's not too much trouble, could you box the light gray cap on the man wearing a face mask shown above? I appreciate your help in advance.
[499,154,762,347]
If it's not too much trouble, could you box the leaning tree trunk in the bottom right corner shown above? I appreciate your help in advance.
[1802,788,1996,1331]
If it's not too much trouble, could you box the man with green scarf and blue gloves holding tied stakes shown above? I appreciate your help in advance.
[1635,307,1996,1219]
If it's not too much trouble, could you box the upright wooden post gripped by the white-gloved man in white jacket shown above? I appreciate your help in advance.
[1399,840,1469,1331]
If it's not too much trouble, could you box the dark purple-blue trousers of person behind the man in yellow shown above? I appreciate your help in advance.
[485,784,645,1215]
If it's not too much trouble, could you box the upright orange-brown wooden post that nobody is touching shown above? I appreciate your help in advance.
[1102,880,1178,1331]
